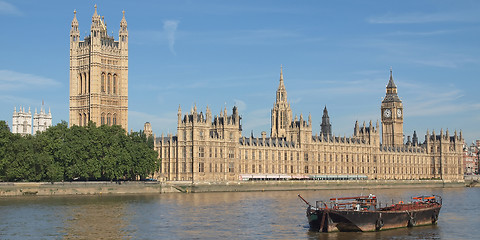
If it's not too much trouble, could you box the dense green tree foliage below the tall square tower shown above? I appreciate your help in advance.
[0,121,160,182]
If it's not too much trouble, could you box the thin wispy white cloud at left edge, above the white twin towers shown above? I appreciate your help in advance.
[0,70,60,91]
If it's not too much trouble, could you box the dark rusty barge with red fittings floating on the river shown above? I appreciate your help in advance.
[298,194,442,232]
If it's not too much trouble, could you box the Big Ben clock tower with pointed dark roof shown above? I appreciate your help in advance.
[381,68,403,146]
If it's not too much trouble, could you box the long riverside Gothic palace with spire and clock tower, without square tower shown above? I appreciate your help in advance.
[155,67,463,182]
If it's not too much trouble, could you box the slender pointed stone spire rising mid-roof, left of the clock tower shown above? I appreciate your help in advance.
[270,66,292,138]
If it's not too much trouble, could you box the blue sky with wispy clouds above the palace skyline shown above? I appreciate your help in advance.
[0,0,480,143]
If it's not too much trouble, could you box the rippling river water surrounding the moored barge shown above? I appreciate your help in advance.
[0,188,480,240]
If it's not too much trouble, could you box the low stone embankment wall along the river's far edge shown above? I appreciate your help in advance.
[0,180,465,197]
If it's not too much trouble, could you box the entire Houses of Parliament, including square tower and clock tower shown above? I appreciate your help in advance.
[69,6,464,182]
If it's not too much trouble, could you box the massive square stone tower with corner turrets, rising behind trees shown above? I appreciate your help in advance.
[70,5,128,130]
